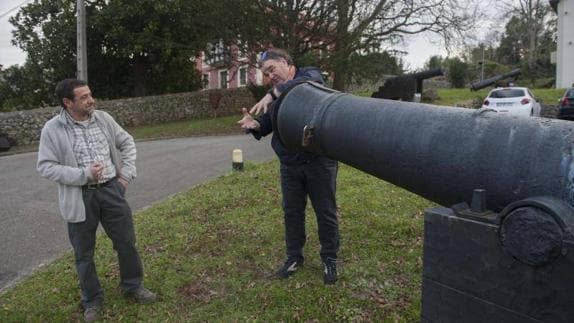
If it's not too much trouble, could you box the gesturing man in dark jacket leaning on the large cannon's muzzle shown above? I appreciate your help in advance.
[239,48,339,284]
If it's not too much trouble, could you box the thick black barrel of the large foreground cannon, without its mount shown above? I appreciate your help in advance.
[274,83,574,212]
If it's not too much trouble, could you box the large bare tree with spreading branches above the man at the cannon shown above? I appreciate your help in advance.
[232,0,479,90]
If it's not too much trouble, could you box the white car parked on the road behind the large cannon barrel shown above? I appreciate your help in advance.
[482,87,541,117]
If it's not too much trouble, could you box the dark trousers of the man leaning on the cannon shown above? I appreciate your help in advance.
[281,157,339,261]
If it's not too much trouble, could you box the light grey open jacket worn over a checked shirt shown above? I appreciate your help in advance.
[37,109,136,223]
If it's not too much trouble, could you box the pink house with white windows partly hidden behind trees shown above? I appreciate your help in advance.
[196,41,263,90]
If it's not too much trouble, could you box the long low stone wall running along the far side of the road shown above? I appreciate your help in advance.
[0,88,255,146]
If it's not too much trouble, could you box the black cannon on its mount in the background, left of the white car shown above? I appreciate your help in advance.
[371,68,444,101]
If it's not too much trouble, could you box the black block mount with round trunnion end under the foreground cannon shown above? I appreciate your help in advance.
[421,198,574,323]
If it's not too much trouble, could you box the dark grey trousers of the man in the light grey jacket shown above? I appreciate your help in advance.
[68,179,143,307]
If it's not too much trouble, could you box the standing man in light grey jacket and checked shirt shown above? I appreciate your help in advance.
[38,79,156,322]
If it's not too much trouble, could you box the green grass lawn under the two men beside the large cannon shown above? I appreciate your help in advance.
[0,162,432,322]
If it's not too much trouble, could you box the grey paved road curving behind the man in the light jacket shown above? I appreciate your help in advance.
[0,136,274,292]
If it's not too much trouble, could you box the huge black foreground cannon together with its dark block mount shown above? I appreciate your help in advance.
[273,83,574,322]
